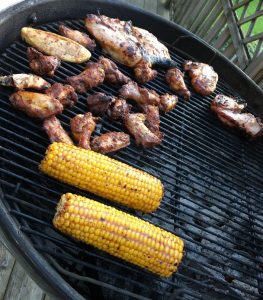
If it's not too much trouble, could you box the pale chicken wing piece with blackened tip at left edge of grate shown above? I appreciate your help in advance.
[0,74,50,91]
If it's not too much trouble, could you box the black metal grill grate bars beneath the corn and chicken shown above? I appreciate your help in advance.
[0,21,263,299]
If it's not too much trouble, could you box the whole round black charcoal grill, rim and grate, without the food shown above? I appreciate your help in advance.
[0,0,263,299]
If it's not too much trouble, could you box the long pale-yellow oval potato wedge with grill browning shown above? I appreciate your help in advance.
[21,27,91,63]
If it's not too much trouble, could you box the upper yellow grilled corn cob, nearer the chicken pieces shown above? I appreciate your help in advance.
[40,143,163,212]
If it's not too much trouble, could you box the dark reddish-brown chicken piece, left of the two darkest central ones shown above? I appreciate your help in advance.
[87,92,113,117]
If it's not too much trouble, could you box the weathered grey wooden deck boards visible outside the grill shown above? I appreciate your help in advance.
[0,0,169,300]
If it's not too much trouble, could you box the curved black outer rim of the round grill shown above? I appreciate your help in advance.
[0,0,263,299]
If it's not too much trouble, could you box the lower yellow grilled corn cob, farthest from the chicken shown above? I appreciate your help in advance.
[53,193,184,277]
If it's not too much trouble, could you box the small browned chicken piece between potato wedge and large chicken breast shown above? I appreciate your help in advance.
[58,25,96,50]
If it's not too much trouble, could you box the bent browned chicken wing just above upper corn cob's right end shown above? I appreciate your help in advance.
[124,113,161,148]
